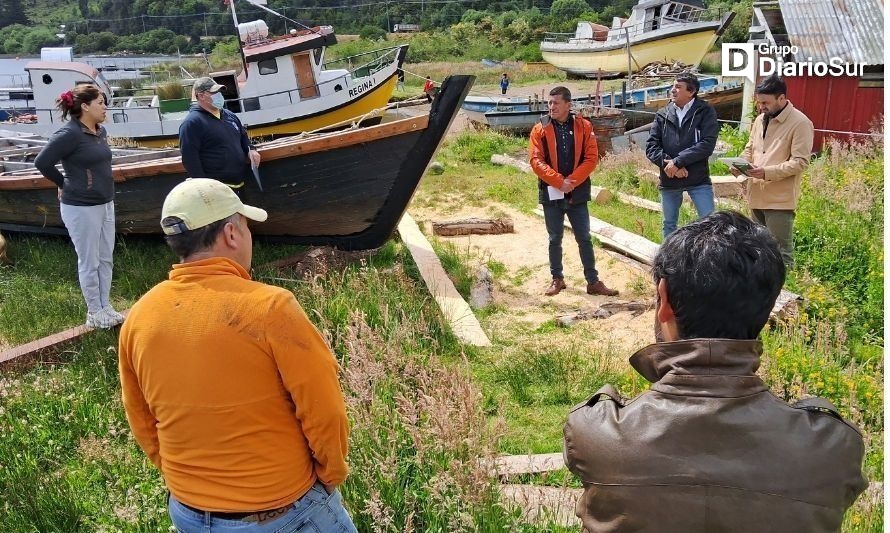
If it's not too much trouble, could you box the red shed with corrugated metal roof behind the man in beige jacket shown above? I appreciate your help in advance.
[742,0,884,150]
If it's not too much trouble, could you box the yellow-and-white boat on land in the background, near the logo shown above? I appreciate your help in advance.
[541,0,735,78]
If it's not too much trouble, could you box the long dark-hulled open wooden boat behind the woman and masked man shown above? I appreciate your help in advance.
[0,76,475,249]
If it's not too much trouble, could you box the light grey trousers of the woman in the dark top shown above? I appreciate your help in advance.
[60,202,114,313]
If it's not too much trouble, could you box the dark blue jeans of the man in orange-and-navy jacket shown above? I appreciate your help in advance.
[541,200,599,283]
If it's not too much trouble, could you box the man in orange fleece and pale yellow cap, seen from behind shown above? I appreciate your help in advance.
[119,178,355,532]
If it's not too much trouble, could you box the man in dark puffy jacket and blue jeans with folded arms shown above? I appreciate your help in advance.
[646,74,720,238]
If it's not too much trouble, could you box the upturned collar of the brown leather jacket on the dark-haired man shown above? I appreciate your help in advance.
[630,339,767,398]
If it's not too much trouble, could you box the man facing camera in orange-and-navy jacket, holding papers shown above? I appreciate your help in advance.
[528,87,618,296]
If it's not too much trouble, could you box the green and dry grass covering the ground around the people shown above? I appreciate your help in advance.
[0,127,884,533]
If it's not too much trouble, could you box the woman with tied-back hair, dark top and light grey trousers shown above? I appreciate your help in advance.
[34,84,124,328]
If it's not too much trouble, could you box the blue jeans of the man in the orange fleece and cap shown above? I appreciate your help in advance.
[167,483,356,533]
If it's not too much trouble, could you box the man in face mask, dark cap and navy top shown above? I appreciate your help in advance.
[179,78,260,192]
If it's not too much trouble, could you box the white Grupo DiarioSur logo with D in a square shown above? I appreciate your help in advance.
[720,43,865,83]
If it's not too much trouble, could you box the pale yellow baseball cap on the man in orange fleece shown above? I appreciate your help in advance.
[161,178,269,235]
